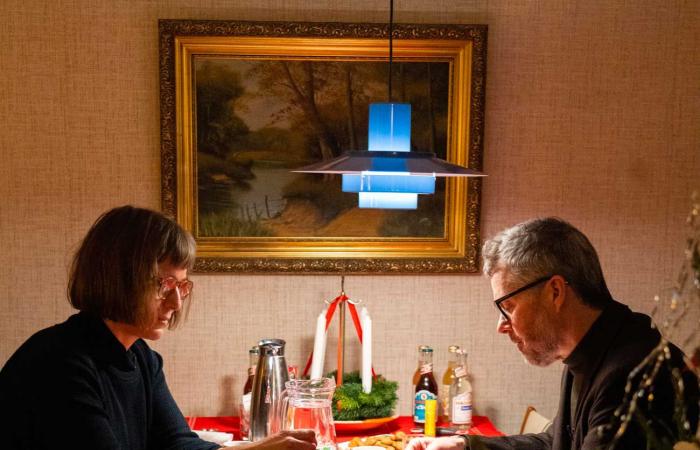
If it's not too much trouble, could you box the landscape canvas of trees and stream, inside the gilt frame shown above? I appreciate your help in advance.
[194,57,449,241]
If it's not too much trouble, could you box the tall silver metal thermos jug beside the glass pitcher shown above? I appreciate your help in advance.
[249,339,289,441]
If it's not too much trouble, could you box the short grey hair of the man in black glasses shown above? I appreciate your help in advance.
[482,217,612,308]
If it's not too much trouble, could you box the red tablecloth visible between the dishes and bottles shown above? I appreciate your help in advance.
[187,416,503,442]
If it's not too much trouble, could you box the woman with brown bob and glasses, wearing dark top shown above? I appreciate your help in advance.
[0,206,315,450]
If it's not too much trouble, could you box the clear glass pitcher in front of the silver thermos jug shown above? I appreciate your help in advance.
[279,378,338,450]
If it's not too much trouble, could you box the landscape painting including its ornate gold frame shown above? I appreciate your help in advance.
[159,20,487,274]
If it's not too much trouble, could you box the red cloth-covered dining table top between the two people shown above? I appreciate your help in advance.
[186,416,504,443]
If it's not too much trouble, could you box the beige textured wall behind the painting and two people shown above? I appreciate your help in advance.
[0,0,700,432]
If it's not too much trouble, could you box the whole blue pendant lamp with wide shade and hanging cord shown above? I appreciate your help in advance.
[292,0,486,209]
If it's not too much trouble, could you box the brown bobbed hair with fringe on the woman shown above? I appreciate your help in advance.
[68,205,195,328]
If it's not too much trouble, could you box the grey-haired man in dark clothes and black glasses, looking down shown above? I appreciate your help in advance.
[407,218,698,450]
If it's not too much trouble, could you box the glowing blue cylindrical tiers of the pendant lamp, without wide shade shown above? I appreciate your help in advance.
[343,103,435,209]
